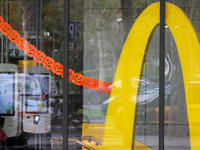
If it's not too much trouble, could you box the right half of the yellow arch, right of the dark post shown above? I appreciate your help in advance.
[166,3,200,150]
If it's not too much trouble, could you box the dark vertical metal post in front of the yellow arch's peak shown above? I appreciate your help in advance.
[159,0,165,150]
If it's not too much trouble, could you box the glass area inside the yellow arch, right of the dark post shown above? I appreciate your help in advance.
[165,26,190,150]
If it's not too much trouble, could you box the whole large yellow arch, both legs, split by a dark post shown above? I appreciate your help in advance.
[103,2,200,150]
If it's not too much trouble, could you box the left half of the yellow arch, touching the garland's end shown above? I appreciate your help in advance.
[103,3,160,150]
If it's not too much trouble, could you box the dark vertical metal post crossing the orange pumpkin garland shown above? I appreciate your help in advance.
[63,0,69,150]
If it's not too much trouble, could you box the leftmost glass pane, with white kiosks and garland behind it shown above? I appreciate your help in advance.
[0,0,63,150]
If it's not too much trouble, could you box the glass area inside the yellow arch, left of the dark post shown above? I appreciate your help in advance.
[135,26,159,149]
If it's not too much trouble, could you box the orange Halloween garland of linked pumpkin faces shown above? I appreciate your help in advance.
[0,16,112,94]
